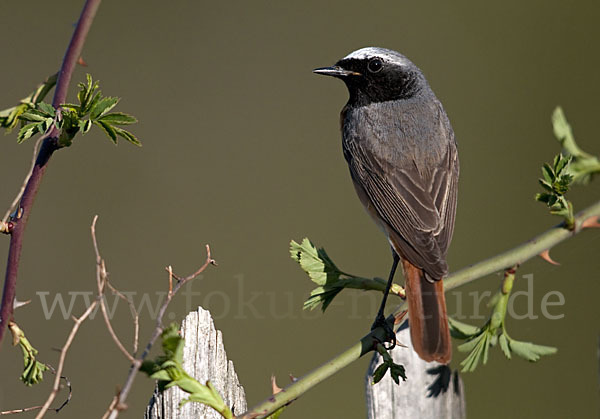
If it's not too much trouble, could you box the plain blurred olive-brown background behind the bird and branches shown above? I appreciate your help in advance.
[0,0,600,419]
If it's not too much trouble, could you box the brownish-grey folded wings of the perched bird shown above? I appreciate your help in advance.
[346,131,458,279]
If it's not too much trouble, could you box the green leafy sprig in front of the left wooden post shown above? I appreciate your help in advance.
[140,323,234,419]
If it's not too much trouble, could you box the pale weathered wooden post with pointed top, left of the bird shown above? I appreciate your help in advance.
[144,307,247,419]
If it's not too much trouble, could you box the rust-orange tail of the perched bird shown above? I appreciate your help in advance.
[402,260,452,364]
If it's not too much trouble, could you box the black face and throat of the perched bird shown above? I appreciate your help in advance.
[335,57,424,106]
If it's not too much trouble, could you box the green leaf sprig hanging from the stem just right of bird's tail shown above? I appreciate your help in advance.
[449,269,557,372]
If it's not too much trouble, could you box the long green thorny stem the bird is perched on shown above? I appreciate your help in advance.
[237,201,600,419]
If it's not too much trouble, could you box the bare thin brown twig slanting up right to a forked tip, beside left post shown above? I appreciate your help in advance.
[102,244,217,419]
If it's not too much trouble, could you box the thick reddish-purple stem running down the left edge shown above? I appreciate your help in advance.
[0,0,101,350]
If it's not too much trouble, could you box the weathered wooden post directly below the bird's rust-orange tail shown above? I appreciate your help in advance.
[366,327,466,419]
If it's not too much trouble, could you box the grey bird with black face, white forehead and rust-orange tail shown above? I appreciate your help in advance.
[313,47,459,364]
